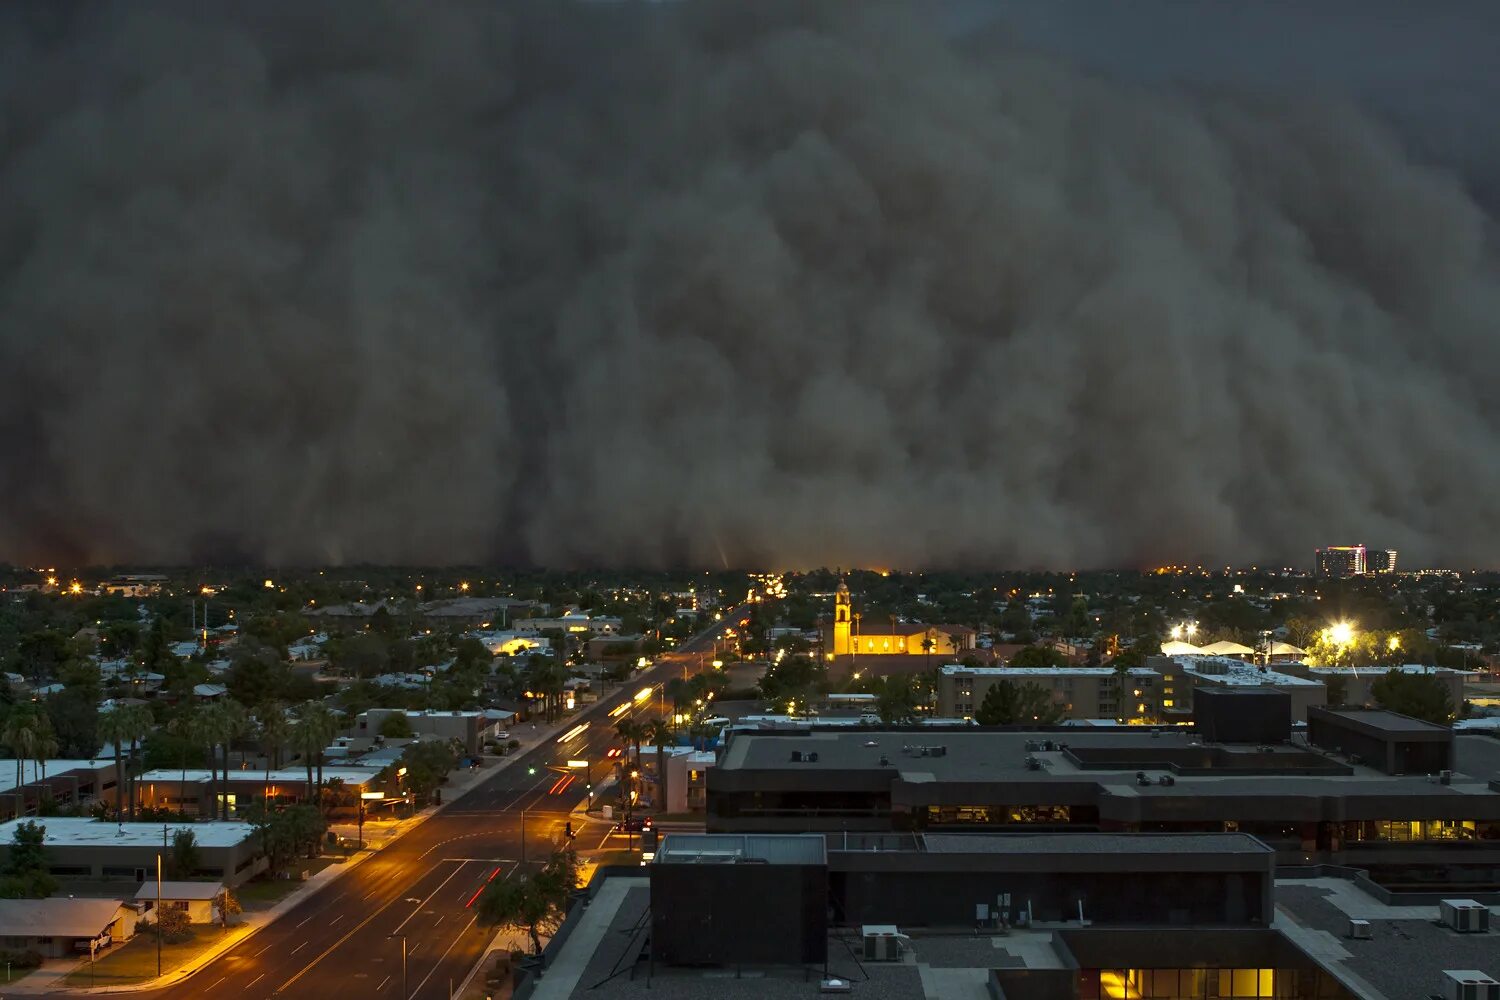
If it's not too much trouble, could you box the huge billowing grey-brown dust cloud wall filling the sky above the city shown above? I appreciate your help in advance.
[0,0,1500,568]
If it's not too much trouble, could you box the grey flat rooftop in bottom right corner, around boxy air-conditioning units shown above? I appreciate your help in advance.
[1274,879,1500,1000]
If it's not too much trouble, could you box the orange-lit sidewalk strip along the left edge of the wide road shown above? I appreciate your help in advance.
[5,712,578,994]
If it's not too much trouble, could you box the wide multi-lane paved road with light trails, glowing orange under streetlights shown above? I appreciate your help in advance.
[43,609,743,1000]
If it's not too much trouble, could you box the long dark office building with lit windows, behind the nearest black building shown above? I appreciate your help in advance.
[707,722,1500,885]
